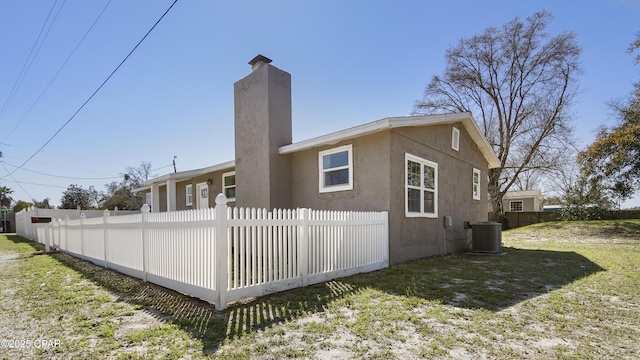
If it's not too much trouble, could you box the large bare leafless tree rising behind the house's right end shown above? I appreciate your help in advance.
[414,11,582,218]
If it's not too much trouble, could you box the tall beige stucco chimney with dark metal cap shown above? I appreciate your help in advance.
[234,55,292,209]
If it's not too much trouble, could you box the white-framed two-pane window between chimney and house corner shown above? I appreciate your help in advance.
[318,145,353,193]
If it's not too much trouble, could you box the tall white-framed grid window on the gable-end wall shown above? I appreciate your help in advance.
[405,153,438,218]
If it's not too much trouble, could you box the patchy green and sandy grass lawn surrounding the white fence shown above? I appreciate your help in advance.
[0,220,640,359]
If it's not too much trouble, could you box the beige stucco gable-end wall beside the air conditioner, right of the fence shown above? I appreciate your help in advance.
[389,124,488,263]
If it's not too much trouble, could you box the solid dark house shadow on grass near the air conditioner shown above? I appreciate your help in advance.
[349,248,604,311]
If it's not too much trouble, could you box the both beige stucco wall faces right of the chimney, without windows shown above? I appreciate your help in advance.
[289,124,488,263]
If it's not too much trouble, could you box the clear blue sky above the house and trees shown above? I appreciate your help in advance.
[0,0,640,206]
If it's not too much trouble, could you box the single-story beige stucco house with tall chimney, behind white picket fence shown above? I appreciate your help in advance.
[137,55,500,263]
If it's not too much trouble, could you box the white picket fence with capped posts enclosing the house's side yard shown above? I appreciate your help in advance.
[16,194,389,310]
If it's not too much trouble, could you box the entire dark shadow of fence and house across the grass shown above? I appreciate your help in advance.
[37,239,604,354]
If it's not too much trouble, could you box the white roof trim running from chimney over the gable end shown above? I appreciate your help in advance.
[278,112,500,169]
